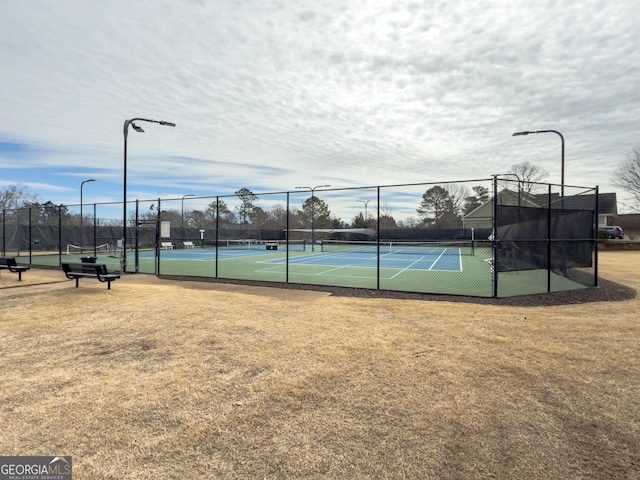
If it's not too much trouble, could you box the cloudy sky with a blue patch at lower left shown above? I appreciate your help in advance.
[0,0,640,216]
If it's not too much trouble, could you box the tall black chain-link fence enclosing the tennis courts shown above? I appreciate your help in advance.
[0,179,598,297]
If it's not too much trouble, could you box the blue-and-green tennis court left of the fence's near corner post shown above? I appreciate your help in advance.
[139,241,492,296]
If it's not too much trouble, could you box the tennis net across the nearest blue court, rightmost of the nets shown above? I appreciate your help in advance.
[321,240,475,255]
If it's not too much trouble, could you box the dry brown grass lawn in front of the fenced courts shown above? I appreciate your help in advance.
[0,252,640,480]
